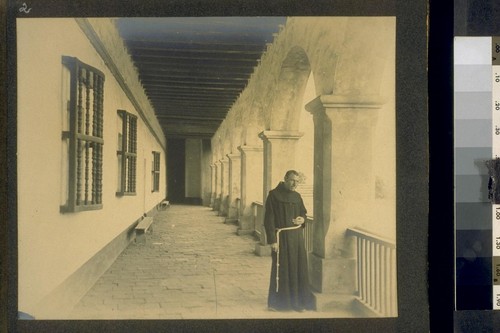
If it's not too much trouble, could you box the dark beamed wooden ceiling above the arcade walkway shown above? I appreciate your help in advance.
[117,17,286,139]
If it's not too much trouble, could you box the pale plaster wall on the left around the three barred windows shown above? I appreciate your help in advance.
[17,18,165,316]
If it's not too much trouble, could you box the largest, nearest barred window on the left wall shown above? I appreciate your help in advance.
[61,56,104,213]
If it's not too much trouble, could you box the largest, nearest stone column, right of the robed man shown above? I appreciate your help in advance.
[306,95,382,294]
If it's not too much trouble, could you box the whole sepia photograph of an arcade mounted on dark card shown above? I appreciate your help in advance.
[16,14,399,320]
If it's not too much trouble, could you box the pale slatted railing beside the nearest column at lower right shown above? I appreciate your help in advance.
[346,228,398,317]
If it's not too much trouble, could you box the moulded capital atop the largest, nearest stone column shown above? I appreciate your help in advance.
[305,95,386,114]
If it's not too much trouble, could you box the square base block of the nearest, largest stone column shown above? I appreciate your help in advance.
[309,253,356,295]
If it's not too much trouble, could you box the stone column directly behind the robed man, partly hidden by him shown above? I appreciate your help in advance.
[255,131,304,255]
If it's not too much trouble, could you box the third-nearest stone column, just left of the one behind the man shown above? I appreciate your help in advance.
[237,145,264,235]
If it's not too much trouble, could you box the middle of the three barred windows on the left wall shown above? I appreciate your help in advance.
[116,110,137,196]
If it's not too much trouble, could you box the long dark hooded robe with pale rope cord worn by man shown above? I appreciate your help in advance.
[264,182,314,311]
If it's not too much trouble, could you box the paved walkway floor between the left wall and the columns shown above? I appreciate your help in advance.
[72,205,344,319]
